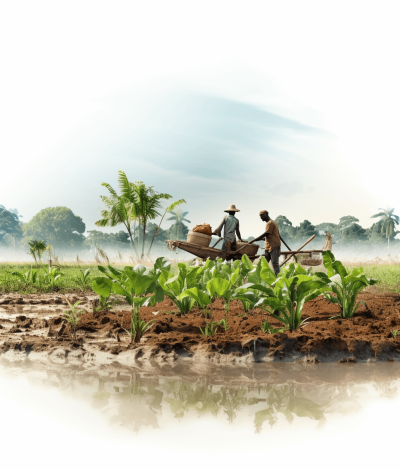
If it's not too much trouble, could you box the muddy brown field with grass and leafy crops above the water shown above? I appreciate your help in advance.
[0,253,400,363]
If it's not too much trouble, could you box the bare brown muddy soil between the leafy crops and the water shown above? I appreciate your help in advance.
[0,293,400,364]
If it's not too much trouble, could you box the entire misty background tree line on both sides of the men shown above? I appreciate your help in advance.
[0,177,400,257]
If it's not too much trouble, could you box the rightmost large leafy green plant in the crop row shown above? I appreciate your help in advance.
[322,251,377,318]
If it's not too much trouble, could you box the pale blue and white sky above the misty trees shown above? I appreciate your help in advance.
[0,0,400,237]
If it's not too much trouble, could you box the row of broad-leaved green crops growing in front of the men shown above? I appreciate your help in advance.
[92,251,377,342]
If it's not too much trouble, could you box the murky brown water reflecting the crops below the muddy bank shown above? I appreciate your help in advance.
[1,360,400,433]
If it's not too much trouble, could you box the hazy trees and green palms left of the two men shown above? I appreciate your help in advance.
[0,171,189,257]
